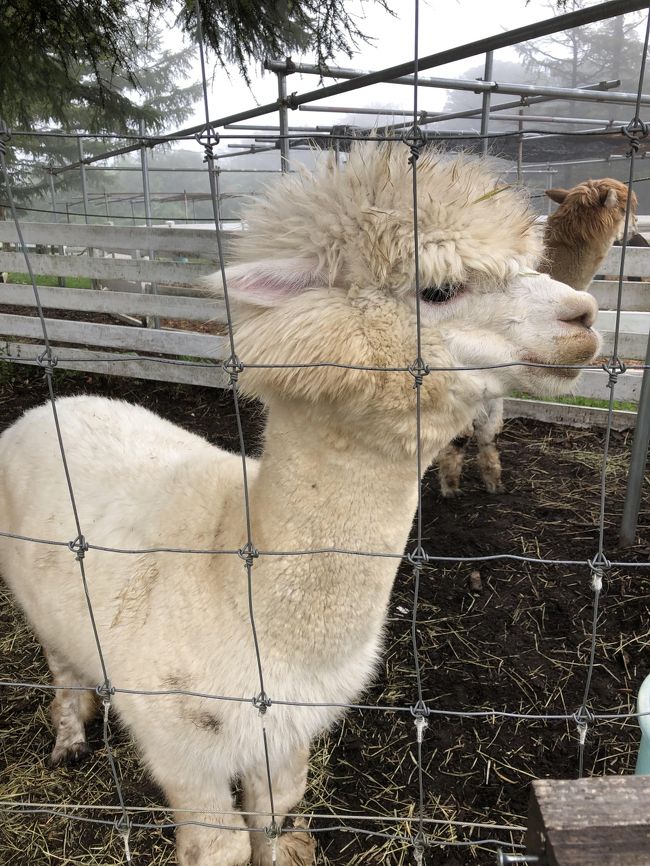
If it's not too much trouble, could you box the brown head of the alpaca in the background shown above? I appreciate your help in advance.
[546,177,637,244]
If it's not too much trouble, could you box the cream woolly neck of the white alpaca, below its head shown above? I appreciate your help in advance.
[233,396,417,666]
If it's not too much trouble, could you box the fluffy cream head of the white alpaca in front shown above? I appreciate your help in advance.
[211,143,598,450]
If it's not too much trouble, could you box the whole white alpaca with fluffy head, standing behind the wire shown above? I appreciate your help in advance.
[0,144,598,866]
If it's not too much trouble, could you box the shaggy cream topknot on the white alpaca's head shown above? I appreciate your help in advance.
[234,142,541,292]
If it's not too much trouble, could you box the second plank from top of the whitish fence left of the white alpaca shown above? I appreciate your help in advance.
[0,252,216,285]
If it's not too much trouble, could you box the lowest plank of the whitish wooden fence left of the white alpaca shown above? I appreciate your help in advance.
[0,342,230,388]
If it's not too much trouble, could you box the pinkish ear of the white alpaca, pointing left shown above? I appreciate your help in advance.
[208,259,326,307]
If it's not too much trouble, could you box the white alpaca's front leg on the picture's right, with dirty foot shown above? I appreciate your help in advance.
[242,749,316,866]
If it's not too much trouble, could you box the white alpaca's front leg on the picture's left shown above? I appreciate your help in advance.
[163,769,251,866]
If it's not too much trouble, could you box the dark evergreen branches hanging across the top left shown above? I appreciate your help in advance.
[0,0,388,128]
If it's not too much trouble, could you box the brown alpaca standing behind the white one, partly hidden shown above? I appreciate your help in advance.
[438,177,637,496]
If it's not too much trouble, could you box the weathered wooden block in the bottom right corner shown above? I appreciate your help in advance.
[526,776,650,866]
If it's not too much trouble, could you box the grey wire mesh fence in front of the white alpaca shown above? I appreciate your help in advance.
[0,0,650,863]
